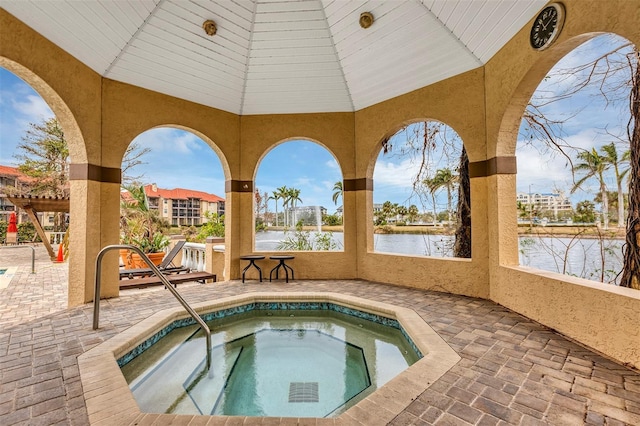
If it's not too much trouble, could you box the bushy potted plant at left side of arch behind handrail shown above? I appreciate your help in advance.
[120,186,169,268]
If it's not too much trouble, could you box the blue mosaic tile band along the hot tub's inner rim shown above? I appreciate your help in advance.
[117,302,423,367]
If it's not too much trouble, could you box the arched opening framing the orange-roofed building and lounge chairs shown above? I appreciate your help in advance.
[120,127,227,282]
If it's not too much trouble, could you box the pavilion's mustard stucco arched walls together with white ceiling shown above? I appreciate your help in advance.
[0,0,640,390]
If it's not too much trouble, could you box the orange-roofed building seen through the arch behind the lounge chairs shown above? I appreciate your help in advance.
[144,183,225,226]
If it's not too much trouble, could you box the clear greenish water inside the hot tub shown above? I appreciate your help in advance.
[120,309,420,417]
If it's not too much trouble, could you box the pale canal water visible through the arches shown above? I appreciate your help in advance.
[256,231,624,282]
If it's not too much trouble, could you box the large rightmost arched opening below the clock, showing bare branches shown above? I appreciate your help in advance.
[516,34,637,284]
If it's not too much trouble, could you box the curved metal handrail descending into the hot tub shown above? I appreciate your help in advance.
[93,244,211,370]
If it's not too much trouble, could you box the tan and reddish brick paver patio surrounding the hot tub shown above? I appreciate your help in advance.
[0,245,640,426]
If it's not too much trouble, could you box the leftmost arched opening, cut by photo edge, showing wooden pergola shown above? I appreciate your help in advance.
[0,62,86,309]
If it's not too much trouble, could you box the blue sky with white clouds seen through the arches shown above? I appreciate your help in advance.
[0,32,624,212]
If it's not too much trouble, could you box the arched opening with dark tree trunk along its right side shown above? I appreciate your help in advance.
[373,120,471,257]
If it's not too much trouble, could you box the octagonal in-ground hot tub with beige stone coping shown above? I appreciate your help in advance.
[79,293,460,424]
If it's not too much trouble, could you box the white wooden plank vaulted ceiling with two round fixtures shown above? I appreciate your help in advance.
[0,0,546,114]
